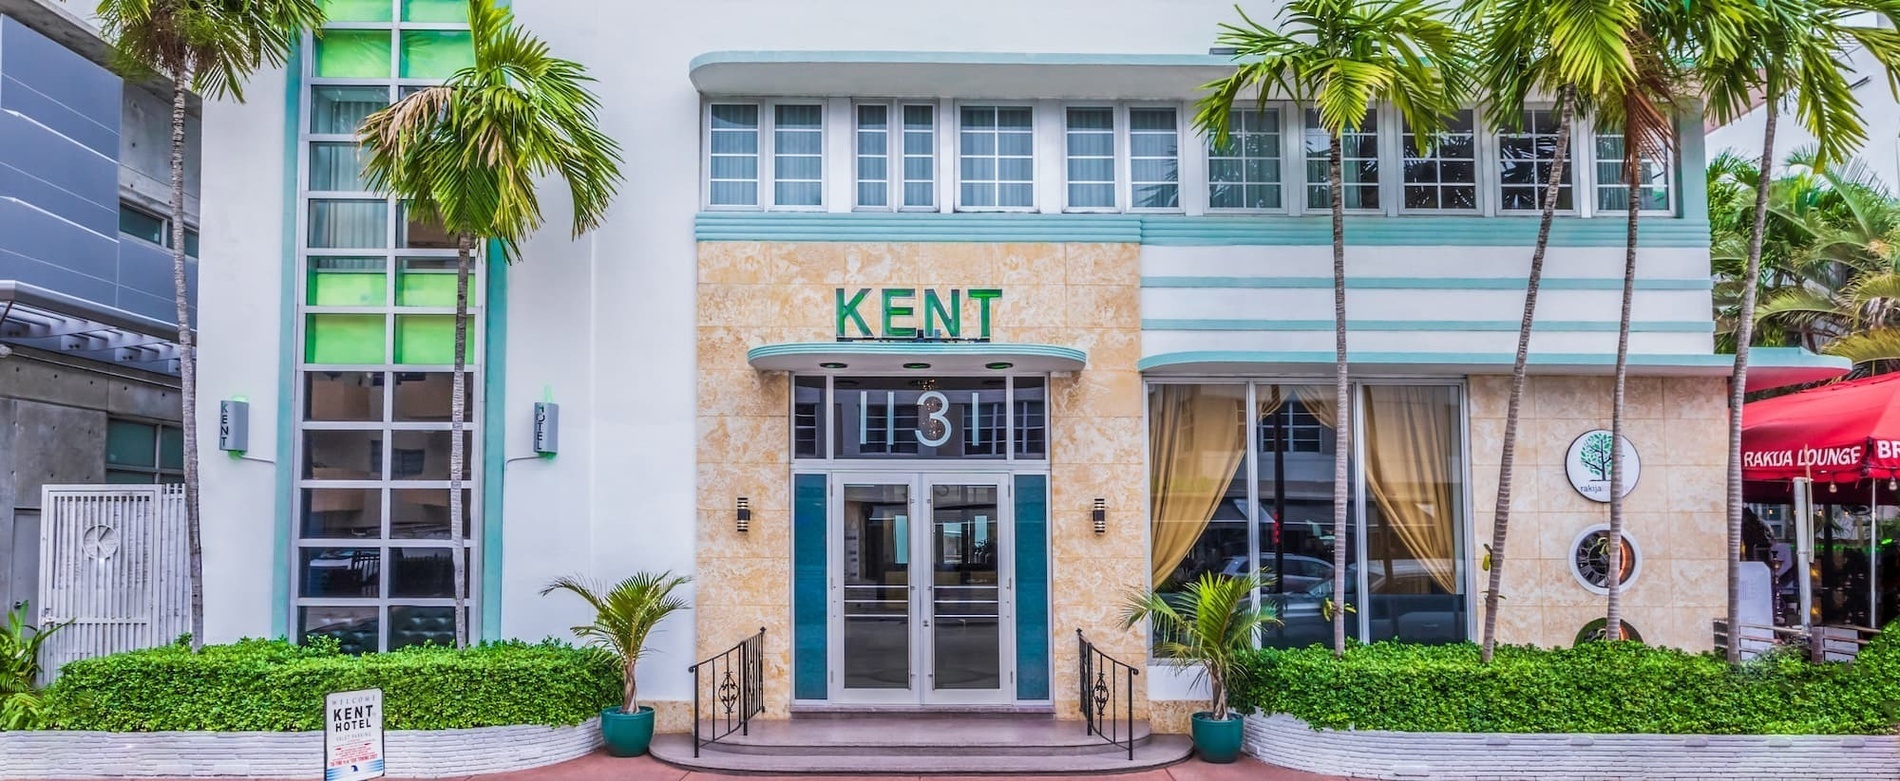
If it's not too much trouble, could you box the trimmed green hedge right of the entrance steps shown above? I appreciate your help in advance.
[1231,625,1900,735]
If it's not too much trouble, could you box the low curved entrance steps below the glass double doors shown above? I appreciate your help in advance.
[652,709,1191,775]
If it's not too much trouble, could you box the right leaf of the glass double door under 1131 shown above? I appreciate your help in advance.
[927,477,1007,701]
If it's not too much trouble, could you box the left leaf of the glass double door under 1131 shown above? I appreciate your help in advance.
[838,483,916,703]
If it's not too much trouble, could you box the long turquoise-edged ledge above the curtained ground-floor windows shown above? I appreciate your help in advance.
[1140,348,1853,391]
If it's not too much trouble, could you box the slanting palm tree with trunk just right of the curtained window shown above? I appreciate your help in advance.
[1463,0,1642,663]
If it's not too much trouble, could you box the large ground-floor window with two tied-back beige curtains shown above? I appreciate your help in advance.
[1148,384,1469,646]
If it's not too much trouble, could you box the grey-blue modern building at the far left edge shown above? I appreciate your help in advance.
[0,0,198,606]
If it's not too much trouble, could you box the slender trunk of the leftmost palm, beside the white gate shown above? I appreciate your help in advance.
[171,67,205,650]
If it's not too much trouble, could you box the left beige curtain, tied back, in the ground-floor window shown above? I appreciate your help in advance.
[1148,386,1246,585]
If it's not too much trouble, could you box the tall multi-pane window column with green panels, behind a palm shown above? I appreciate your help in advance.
[289,0,485,652]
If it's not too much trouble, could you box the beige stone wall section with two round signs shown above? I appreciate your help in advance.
[1467,376,1727,650]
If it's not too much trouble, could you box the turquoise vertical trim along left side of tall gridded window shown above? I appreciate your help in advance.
[270,42,304,640]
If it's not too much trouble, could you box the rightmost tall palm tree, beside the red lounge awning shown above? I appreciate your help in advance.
[1695,0,1900,663]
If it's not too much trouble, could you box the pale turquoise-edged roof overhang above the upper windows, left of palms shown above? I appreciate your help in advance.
[690,51,1233,101]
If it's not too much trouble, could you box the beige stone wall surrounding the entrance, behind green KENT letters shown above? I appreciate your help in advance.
[694,241,1148,716]
